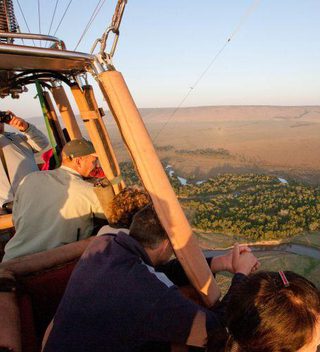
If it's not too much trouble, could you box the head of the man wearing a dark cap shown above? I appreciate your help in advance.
[61,139,97,177]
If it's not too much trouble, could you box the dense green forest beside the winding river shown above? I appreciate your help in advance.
[121,163,320,240]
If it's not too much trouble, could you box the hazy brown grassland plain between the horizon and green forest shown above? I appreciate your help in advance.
[26,106,320,184]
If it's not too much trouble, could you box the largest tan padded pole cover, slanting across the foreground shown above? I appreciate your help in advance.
[97,71,220,306]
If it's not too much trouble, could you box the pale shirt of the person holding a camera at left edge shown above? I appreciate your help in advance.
[0,124,48,207]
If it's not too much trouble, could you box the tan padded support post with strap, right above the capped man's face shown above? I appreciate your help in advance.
[71,85,124,194]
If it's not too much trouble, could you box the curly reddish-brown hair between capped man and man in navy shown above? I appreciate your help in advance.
[108,187,151,228]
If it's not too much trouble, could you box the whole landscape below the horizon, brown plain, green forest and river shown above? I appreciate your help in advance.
[20,102,320,285]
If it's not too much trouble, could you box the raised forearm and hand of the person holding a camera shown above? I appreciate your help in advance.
[9,112,48,152]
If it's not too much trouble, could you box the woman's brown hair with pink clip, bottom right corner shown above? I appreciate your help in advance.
[225,271,320,352]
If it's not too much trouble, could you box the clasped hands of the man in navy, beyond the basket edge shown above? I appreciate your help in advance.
[232,243,260,275]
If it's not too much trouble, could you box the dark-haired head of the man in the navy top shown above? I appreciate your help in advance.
[129,204,173,265]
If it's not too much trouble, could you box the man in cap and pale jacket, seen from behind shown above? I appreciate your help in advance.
[3,139,110,261]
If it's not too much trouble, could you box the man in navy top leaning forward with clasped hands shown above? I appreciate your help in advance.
[44,205,258,352]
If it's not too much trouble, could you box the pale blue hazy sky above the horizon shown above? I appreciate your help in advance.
[1,0,320,117]
